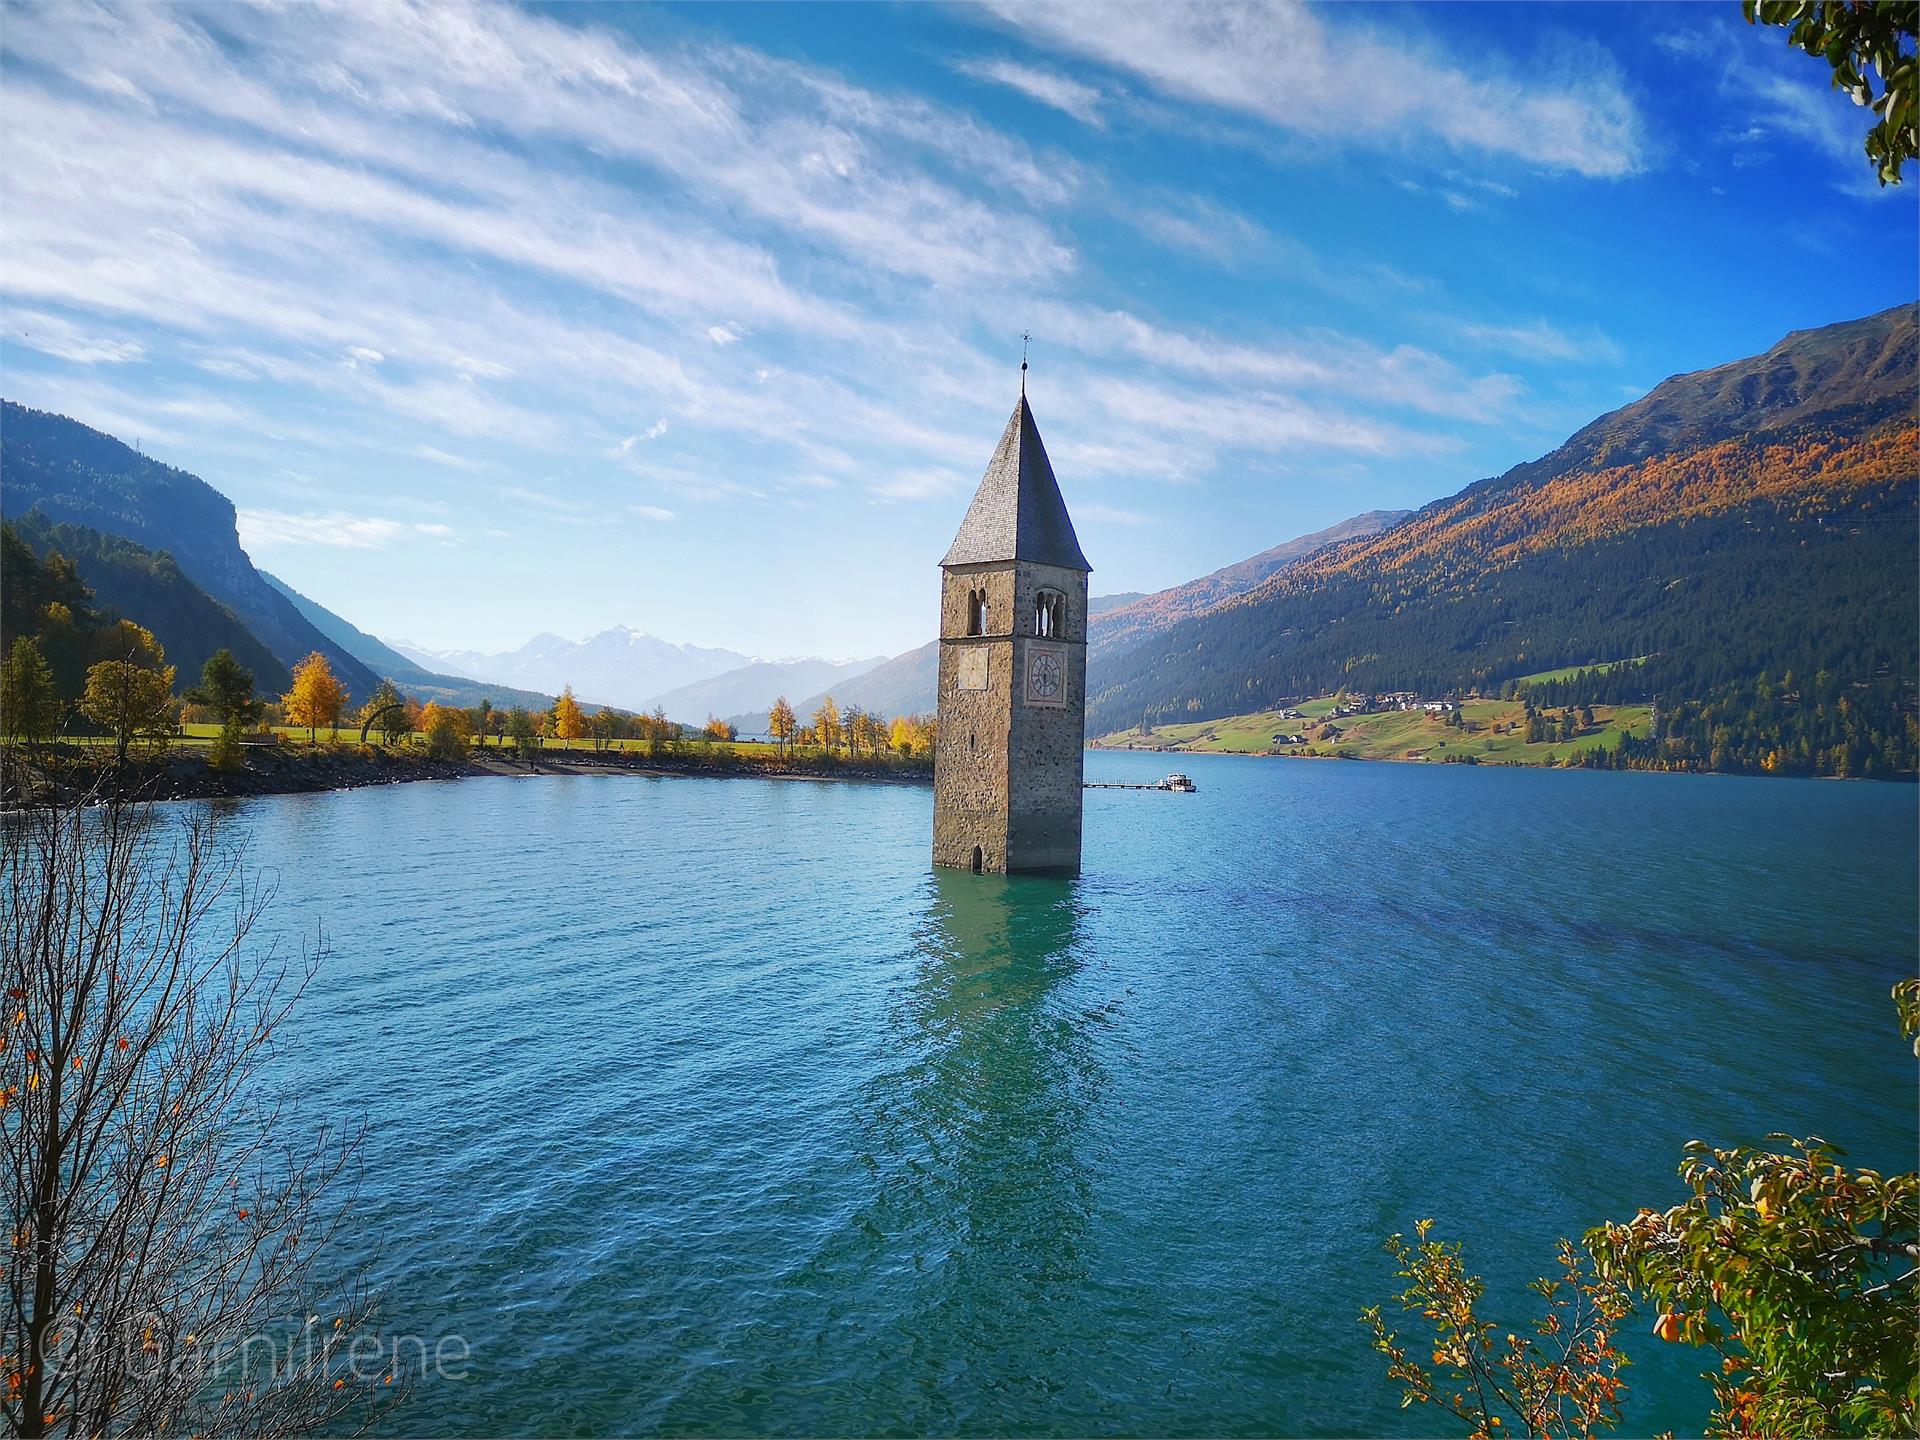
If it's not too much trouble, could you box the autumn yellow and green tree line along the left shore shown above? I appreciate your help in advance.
[0,536,935,804]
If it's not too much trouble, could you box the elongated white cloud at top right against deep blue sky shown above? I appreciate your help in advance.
[975,0,1645,177]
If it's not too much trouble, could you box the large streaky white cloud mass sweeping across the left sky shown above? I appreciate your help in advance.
[0,0,1517,572]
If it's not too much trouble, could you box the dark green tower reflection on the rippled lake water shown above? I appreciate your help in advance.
[837,872,1108,1428]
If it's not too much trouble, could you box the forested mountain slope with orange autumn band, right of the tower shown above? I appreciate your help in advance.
[1089,307,1920,770]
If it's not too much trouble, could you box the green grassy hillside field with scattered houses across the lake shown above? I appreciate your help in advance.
[1096,697,1649,764]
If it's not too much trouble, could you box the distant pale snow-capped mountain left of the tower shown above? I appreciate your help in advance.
[386,626,749,710]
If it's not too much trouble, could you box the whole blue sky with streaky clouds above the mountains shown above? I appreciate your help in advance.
[0,0,1920,657]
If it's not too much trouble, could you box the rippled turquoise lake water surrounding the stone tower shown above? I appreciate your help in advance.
[202,753,1920,1434]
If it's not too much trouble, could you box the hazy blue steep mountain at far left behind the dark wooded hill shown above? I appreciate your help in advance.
[0,401,378,697]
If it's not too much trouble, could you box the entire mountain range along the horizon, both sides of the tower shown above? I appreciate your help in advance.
[0,305,1920,774]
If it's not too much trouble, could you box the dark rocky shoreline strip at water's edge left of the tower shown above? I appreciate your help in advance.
[0,745,933,810]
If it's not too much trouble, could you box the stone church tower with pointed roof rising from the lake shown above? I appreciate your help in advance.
[933,389,1091,874]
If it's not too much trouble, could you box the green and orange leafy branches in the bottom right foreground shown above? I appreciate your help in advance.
[1361,979,1920,1440]
